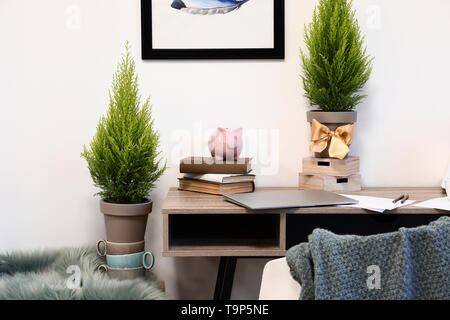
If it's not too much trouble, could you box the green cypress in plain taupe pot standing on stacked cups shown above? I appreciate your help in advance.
[81,42,166,243]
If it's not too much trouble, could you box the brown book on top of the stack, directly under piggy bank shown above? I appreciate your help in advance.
[180,157,252,174]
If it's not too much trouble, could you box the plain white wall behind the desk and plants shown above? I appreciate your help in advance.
[0,0,450,299]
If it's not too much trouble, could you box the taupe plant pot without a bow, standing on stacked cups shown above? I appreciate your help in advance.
[100,200,153,243]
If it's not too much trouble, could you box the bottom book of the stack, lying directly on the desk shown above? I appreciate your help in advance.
[178,178,255,195]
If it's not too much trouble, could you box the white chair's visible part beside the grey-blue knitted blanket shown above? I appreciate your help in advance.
[259,258,301,300]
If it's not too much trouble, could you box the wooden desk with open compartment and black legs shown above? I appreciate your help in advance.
[162,188,448,299]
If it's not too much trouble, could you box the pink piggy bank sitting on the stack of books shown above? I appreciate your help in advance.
[208,128,243,160]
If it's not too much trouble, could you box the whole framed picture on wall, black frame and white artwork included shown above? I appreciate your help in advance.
[141,0,284,59]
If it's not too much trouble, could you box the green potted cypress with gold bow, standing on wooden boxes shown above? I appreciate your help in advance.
[300,0,373,158]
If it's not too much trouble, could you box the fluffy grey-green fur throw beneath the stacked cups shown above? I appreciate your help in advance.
[0,247,165,300]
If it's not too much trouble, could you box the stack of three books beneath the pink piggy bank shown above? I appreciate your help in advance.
[178,157,255,195]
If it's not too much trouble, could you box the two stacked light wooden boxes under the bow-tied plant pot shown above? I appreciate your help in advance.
[299,157,361,192]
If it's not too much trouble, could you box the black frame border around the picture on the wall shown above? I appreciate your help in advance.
[141,0,285,60]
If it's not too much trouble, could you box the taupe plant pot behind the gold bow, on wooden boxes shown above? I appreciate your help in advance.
[306,110,358,158]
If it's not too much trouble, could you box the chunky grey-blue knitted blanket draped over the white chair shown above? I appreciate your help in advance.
[286,216,450,300]
